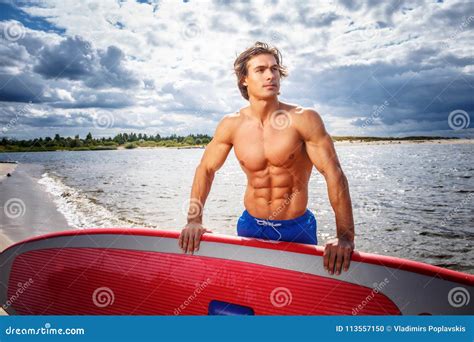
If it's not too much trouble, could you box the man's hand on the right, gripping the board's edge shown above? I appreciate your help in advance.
[323,238,354,275]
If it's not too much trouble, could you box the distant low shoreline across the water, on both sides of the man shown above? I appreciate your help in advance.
[0,137,474,153]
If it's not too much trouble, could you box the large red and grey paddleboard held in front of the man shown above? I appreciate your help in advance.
[0,228,474,315]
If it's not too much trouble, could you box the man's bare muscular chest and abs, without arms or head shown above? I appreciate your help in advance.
[227,104,313,220]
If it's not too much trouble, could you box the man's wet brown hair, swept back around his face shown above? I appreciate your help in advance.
[234,42,288,100]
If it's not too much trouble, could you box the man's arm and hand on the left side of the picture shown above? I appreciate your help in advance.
[179,117,233,253]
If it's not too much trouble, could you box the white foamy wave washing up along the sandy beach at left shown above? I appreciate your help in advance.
[38,172,136,228]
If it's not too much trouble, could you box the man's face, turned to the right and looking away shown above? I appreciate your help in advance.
[242,54,280,99]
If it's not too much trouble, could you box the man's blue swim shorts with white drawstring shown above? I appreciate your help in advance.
[237,209,318,245]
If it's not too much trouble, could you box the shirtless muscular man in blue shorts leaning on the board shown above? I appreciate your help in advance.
[179,42,354,274]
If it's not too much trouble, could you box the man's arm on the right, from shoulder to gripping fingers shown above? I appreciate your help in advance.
[298,110,354,274]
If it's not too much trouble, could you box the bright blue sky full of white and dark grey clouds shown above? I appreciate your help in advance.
[0,0,474,139]
